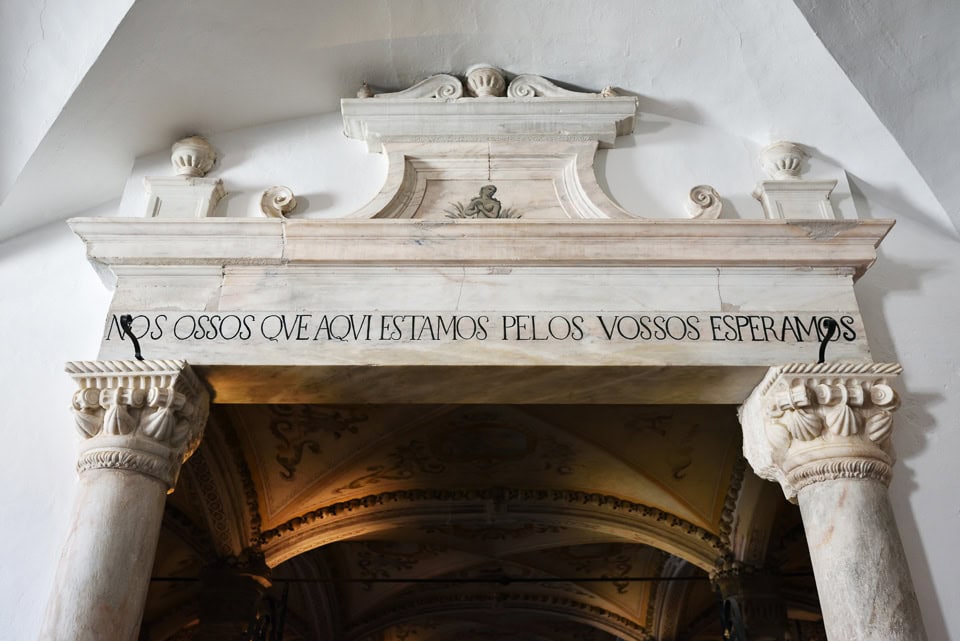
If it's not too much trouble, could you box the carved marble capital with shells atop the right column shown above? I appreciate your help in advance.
[740,363,902,500]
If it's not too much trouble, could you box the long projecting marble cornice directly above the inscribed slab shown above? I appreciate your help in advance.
[70,218,893,277]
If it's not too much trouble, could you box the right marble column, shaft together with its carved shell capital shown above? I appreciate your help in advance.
[740,363,926,641]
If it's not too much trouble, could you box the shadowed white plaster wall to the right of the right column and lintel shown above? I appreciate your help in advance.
[857,188,960,641]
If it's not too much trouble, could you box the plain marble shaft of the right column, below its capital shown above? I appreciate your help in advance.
[798,478,926,641]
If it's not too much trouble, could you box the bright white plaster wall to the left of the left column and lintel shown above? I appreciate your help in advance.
[0,202,117,641]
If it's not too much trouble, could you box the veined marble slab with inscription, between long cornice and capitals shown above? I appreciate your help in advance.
[100,266,869,366]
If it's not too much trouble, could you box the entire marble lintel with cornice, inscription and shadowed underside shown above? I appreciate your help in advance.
[73,220,889,403]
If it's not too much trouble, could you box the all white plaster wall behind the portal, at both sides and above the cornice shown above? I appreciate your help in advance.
[0,115,960,641]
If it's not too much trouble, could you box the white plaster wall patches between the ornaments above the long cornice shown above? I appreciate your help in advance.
[120,114,857,224]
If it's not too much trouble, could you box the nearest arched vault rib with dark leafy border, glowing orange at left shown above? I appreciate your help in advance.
[259,488,726,571]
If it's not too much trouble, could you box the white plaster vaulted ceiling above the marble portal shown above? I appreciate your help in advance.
[0,0,960,238]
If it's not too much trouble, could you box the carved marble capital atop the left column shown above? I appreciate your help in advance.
[67,361,210,491]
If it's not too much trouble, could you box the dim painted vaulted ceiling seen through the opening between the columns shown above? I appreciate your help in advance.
[142,405,819,641]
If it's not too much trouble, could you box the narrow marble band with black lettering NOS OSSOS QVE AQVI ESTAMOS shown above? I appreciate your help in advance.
[103,310,868,364]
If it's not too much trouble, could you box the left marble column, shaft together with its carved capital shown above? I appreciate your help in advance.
[40,361,209,641]
